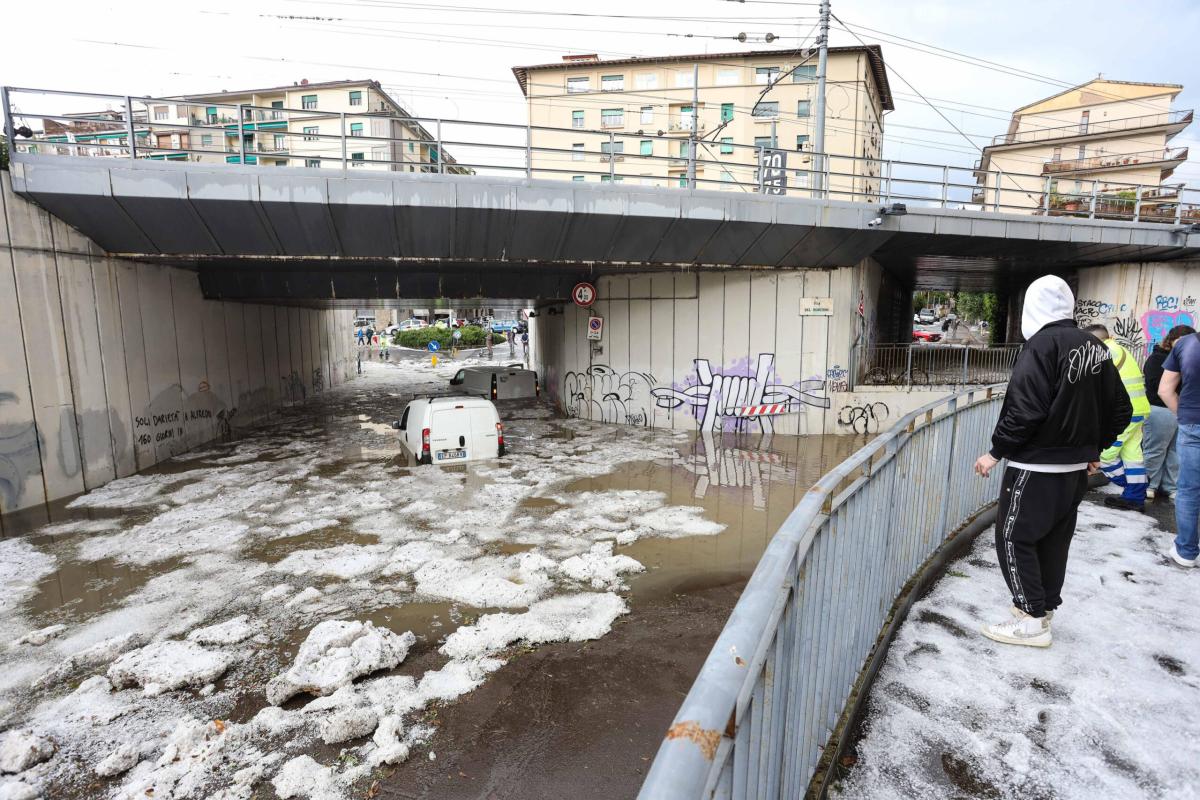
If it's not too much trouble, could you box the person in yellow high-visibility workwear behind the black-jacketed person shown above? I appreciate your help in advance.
[1084,325,1150,511]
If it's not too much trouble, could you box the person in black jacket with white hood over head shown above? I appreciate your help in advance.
[976,275,1133,648]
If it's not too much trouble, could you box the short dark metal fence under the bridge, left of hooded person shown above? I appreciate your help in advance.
[852,344,1021,387]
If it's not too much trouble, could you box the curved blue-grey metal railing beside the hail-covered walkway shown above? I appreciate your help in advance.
[638,386,1002,800]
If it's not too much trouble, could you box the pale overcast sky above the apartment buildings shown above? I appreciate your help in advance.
[0,0,1200,184]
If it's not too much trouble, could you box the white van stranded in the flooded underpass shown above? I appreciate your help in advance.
[391,395,504,464]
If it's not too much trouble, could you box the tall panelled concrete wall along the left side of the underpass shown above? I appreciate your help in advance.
[0,173,354,522]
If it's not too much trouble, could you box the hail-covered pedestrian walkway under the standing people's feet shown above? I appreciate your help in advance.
[832,488,1200,800]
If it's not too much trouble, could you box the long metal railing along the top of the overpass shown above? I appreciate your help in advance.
[0,86,1200,225]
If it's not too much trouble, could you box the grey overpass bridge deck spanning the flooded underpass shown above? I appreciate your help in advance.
[13,155,1200,306]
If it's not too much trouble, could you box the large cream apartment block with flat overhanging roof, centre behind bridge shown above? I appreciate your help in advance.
[512,46,894,200]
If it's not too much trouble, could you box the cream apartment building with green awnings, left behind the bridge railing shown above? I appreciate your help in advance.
[46,80,467,173]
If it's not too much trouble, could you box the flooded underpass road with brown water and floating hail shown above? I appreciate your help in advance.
[0,360,862,800]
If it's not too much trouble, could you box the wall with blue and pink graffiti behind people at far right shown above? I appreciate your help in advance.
[1075,261,1200,347]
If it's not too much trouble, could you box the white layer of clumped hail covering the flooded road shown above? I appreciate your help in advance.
[0,361,722,800]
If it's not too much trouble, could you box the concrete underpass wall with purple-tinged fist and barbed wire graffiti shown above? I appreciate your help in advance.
[532,266,902,434]
